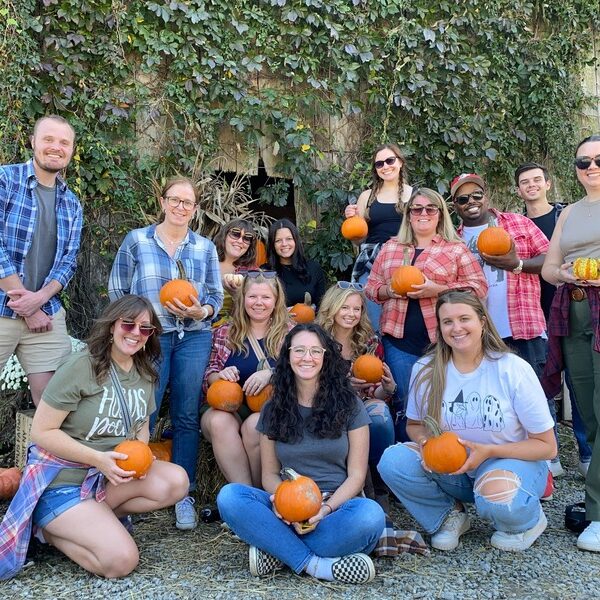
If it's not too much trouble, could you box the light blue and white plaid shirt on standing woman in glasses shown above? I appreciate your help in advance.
[108,225,223,333]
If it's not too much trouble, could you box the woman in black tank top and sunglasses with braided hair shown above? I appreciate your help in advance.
[344,143,412,331]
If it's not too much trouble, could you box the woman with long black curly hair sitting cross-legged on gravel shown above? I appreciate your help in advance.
[217,323,385,583]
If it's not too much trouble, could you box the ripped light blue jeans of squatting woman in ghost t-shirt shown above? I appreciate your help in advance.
[378,443,548,533]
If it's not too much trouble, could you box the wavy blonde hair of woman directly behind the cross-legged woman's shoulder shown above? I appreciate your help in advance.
[316,284,375,358]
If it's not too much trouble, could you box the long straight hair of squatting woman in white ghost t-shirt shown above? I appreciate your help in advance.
[412,290,511,423]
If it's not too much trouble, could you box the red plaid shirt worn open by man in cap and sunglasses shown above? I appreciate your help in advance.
[458,208,549,340]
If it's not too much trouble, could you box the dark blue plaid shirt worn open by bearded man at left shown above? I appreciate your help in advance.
[0,160,83,319]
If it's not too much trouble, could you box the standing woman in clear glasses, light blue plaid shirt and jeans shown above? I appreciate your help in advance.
[108,177,223,529]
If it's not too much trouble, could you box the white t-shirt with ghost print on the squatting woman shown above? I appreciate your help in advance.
[406,353,554,444]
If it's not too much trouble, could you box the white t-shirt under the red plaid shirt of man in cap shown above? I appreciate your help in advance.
[462,224,512,338]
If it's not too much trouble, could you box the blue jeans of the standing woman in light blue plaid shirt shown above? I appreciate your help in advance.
[150,329,212,491]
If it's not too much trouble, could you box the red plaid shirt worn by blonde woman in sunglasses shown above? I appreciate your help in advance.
[365,235,487,342]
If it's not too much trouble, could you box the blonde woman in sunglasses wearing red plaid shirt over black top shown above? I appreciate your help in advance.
[365,188,487,441]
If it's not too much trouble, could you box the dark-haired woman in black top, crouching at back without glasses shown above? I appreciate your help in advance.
[263,219,325,307]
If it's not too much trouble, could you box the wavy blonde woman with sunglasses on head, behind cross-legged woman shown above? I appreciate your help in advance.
[316,281,396,512]
